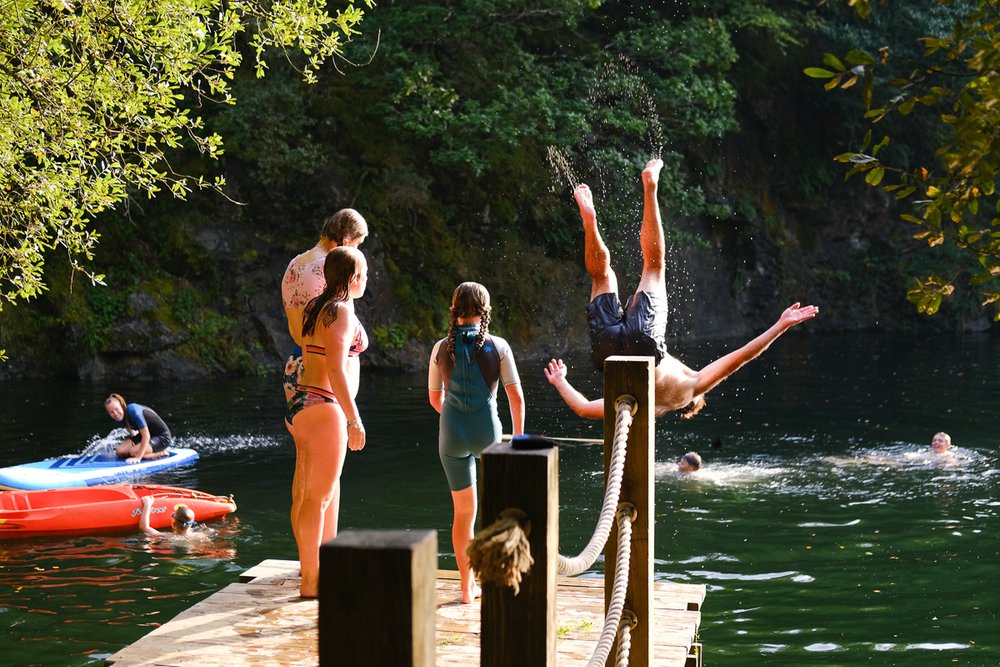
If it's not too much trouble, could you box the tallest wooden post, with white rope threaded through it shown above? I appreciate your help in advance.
[604,356,656,667]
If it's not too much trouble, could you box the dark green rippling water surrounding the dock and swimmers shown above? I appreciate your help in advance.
[0,334,1000,667]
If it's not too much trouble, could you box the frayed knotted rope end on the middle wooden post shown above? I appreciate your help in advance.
[465,508,535,595]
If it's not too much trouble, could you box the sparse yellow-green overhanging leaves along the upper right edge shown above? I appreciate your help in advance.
[805,0,1000,321]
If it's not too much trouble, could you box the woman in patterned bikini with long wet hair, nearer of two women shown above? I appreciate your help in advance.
[286,247,368,598]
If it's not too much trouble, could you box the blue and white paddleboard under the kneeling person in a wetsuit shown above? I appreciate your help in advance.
[0,447,198,491]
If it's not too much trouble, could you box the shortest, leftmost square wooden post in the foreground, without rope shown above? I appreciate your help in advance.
[319,530,437,667]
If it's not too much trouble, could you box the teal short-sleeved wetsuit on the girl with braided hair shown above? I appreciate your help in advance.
[427,324,521,491]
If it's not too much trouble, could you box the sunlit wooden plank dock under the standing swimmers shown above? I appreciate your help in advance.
[106,560,705,667]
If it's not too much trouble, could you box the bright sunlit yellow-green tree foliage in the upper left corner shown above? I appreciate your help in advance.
[0,0,372,307]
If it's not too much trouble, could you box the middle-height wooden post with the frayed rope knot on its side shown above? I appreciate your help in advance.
[480,442,559,667]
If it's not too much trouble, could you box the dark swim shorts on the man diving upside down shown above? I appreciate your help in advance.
[587,292,667,370]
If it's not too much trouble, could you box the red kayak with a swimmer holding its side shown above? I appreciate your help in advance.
[0,484,236,540]
